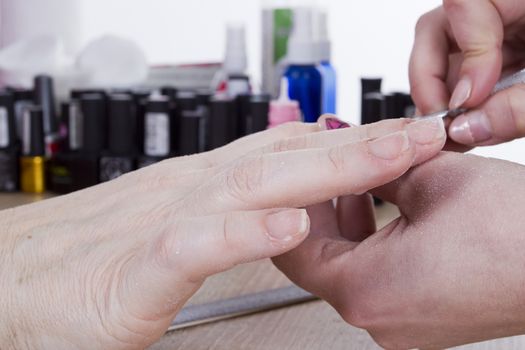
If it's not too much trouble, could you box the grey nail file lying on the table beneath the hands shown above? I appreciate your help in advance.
[168,286,317,332]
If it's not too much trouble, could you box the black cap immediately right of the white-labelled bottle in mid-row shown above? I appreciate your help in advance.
[179,111,204,156]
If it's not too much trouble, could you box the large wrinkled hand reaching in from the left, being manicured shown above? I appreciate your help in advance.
[0,119,445,349]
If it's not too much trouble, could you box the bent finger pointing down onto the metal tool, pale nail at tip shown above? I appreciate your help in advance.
[444,0,504,109]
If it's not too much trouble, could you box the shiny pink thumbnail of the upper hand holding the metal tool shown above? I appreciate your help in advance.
[448,111,492,145]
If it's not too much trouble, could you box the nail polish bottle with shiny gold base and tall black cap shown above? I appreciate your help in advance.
[20,106,46,193]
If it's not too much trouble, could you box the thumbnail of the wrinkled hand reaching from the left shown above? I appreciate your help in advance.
[266,209,310,242]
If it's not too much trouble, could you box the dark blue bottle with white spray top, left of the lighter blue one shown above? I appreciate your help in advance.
[285,8,322,123]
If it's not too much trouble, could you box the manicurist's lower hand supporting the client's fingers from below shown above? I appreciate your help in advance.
[274,153,525,349]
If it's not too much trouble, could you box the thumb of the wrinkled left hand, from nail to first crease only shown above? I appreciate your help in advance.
[166,209,310,280]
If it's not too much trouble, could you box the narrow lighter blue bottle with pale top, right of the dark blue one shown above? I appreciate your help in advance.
[317,11,337,114]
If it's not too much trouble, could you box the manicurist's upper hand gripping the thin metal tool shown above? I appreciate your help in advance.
[410,0,525,146]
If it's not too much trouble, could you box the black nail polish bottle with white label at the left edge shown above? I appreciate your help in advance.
[0,90,19,192]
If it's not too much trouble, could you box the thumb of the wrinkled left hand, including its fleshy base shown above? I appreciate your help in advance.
[123,209,310,321]
